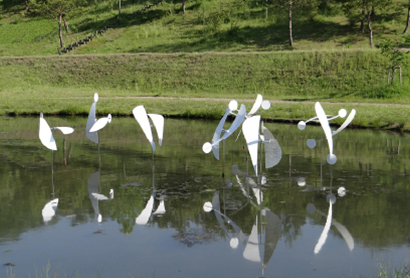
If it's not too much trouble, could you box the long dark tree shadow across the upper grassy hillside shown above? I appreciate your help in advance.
[130,15,363,53]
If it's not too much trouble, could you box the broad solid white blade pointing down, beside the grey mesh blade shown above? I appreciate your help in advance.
[242,115,261,175]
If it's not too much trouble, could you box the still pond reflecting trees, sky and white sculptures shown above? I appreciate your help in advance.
[0,117,410,277]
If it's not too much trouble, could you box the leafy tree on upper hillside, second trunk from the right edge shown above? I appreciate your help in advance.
[339,0,393,47]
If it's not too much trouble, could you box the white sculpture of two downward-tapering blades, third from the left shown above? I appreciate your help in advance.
[132,105,164,152]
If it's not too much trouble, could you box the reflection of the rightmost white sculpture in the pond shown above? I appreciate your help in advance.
[306,176,354,254]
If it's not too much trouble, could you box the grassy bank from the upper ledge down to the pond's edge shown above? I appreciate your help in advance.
[0,50,410,130]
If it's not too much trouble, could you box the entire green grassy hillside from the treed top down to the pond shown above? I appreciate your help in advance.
[0,0,410,130]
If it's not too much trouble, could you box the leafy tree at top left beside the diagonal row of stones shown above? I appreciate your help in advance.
[31,0,86,47]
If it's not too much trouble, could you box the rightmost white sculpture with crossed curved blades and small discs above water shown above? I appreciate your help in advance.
[298,102,356,164]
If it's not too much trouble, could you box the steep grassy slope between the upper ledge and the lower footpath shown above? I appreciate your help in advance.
[0,50,410,103]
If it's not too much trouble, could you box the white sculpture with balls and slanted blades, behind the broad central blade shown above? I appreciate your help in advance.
[202,94,270,176]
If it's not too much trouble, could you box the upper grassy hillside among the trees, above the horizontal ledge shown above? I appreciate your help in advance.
[0,0,407,56]
